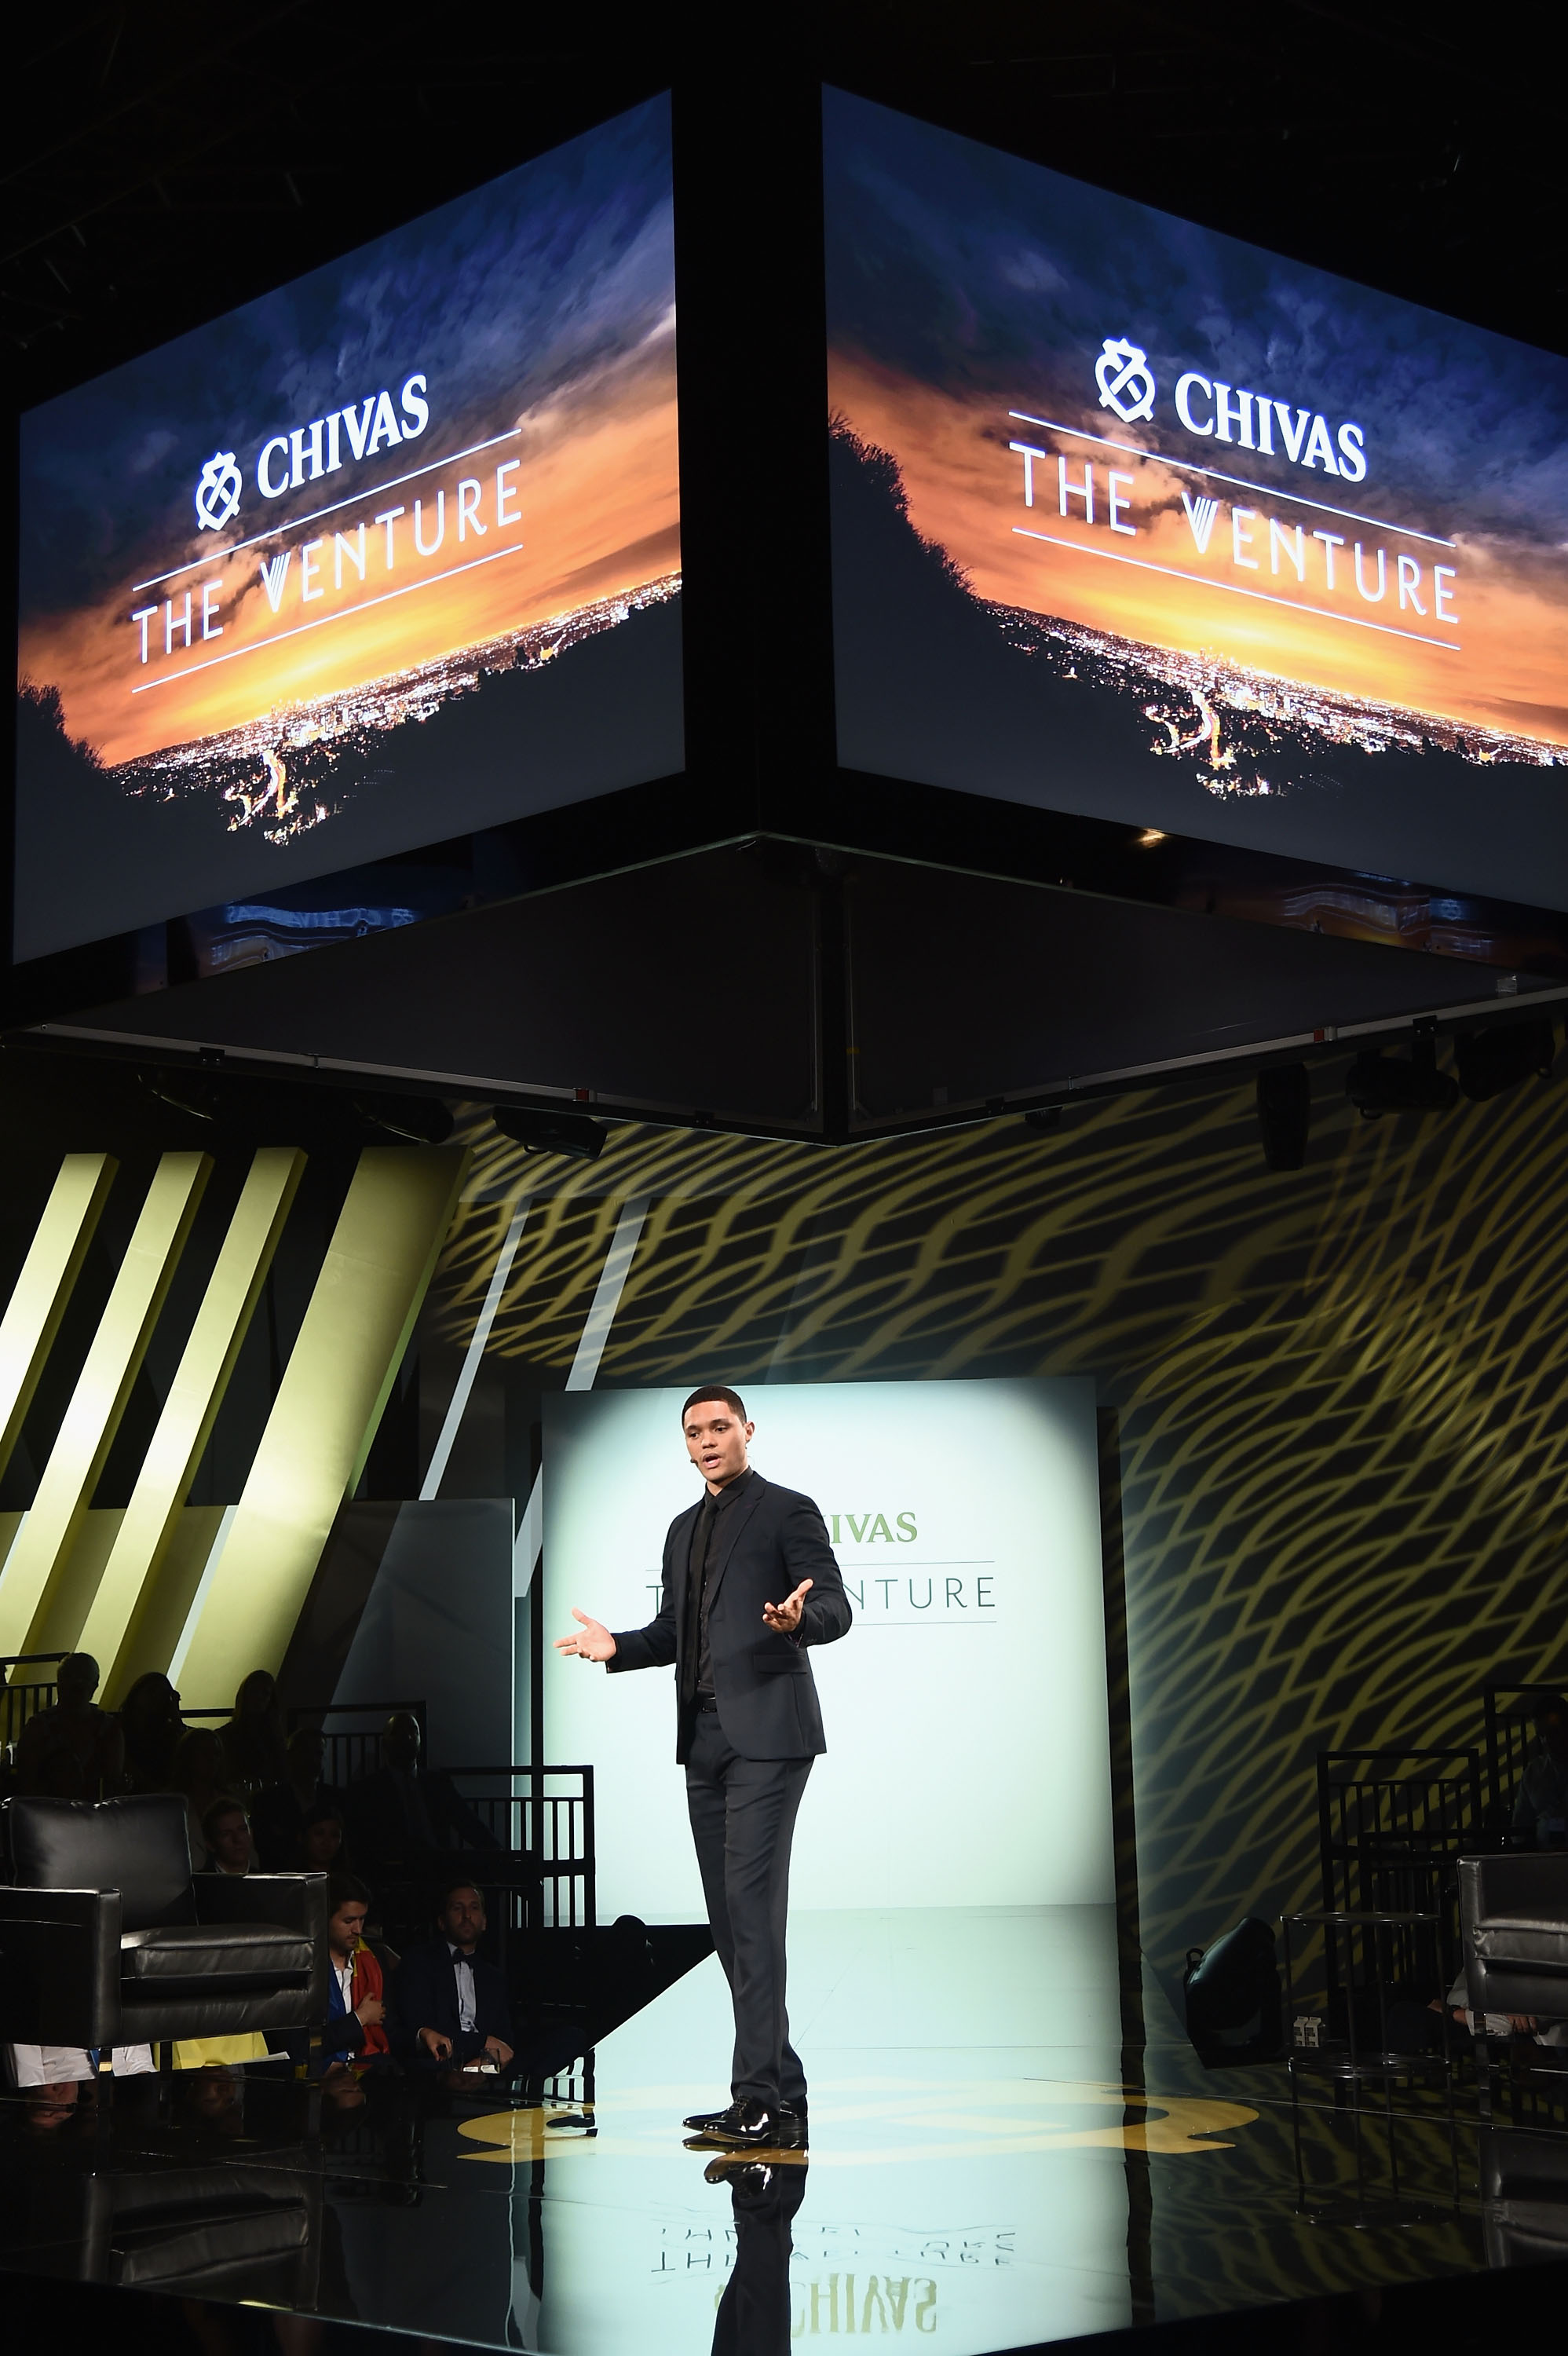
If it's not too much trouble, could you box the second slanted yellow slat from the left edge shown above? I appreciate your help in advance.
[0,1154,212,1652]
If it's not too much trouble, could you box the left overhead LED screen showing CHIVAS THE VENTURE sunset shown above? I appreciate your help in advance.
[14,99,683,959]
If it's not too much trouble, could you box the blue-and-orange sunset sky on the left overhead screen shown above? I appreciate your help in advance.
[19,101,681,766]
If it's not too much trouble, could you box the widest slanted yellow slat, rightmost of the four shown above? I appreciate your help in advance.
[176,1147,469,1694]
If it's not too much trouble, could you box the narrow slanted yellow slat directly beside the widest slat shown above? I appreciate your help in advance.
[90,1145,306,1706]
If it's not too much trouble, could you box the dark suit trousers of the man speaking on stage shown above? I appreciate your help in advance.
[685,1710,812,2104]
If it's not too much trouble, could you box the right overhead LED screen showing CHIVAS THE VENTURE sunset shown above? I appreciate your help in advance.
[826,92,1568,907]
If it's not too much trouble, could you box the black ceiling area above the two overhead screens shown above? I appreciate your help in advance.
[0,0,1568,405]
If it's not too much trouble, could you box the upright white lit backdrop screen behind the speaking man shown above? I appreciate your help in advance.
[542,1381,1113,1922]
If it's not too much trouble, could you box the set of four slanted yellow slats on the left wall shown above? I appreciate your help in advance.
[0,1147,469,1703]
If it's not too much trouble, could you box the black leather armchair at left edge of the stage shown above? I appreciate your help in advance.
[0,1793,327,2045]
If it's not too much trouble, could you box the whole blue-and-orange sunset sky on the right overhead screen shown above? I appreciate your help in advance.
[826,92,1568,747]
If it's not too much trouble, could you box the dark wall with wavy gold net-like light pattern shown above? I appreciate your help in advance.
[438,1065,1568,1967]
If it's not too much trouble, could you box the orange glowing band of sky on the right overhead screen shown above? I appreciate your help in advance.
[828,353,1568,744]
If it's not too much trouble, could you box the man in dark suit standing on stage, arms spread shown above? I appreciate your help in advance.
[556,1383,850,2149]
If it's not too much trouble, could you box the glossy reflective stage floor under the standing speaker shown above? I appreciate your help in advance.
[0,1908,1526,2356]
